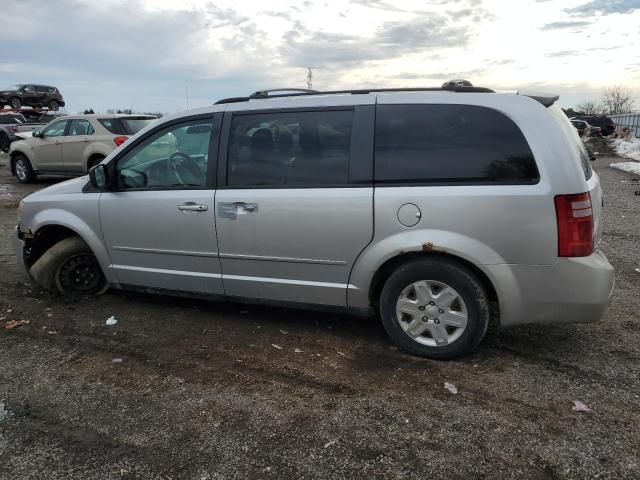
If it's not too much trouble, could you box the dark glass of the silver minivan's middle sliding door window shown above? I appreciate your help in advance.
[227,110,353,187]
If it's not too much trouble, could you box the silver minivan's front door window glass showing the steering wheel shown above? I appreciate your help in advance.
[116,118,213,189]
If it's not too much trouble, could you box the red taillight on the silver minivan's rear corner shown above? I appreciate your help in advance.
[555,192,593,257]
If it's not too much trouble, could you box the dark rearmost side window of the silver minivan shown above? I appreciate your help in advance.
[375,104,540,184]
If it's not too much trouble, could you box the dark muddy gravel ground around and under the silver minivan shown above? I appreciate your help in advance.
[0,140,640,480]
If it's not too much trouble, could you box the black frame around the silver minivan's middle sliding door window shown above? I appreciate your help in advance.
[217,104,375,190]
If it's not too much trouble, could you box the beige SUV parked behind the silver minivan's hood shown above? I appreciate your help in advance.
[9,114,156,183]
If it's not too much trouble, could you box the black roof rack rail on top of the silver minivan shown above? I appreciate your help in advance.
[214,86,495,105]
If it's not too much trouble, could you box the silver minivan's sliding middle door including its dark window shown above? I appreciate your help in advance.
[216,106,373,306]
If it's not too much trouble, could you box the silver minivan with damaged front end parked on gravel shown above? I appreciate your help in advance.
[15,86,613,359]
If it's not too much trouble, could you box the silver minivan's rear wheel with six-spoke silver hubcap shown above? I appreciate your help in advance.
[380,258,490,360]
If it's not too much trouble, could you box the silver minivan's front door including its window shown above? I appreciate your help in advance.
[100,114,223,294]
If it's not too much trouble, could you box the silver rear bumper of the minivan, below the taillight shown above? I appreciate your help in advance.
[487,252,614,326]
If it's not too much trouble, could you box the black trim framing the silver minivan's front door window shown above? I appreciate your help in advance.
[102,112,223,192]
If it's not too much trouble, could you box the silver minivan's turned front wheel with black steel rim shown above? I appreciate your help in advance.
[29,236,108,297]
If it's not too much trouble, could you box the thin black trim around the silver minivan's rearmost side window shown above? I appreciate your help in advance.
[373,103,540,188]
